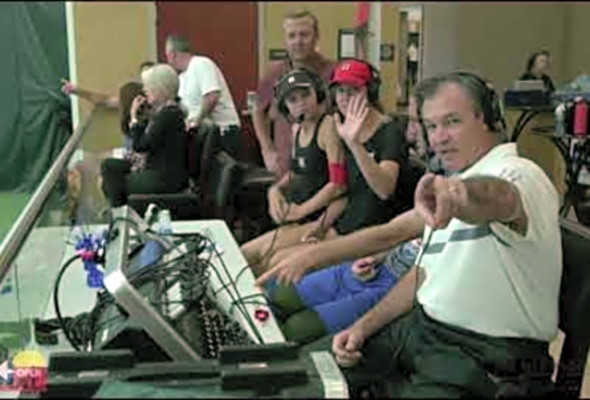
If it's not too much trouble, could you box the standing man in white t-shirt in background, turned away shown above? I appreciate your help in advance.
[166,35,240,156]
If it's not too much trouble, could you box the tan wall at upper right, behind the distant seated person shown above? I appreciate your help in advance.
[420,2,590,90]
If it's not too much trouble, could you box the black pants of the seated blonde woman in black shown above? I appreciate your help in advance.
[101,158,188,207]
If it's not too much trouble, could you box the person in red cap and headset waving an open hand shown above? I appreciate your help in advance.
[254,59,415,276]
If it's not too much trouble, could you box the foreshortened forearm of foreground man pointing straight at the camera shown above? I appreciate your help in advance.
[457,176,524,228]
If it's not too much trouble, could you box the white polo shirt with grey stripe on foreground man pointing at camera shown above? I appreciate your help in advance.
[417,143,562,341]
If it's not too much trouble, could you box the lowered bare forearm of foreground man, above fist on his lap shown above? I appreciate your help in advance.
[353,266,417,337]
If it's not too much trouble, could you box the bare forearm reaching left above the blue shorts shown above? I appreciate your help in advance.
[305,210,424,268]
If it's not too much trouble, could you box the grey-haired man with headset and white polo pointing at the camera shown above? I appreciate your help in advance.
[274,72,562,398]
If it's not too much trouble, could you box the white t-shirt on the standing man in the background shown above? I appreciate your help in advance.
[178,55,240,128]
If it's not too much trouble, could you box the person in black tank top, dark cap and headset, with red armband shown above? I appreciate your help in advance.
[241,69,345,272]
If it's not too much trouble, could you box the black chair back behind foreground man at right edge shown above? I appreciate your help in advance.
[555,219,590,398]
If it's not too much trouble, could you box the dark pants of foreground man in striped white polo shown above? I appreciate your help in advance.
[303,307,553,398]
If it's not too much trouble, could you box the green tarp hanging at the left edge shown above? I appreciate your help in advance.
[0,2,71,192]
